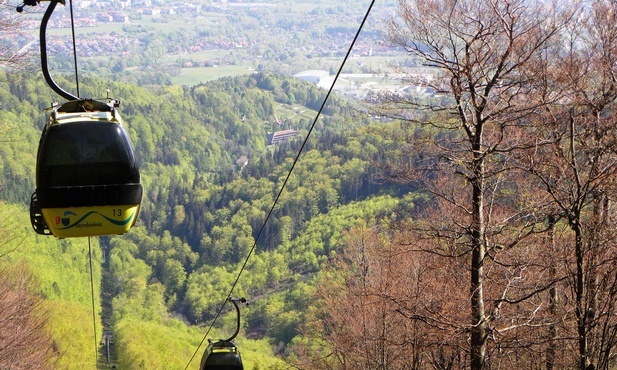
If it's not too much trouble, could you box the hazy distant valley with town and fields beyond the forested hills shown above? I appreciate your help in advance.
[12,0,422,98]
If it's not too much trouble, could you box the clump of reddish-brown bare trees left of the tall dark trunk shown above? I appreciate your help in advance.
[294,227,464,370]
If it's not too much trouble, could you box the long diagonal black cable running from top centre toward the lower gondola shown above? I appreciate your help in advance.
[184,0,375,370]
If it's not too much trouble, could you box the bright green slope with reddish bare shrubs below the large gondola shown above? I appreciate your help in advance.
[0,202,100,369]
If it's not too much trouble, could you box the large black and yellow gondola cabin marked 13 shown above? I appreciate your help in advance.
[30,99,143,238]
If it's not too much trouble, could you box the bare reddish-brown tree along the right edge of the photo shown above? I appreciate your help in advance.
[526,0,617,370]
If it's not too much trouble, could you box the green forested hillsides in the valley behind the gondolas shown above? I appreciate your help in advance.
[0,69,413,369]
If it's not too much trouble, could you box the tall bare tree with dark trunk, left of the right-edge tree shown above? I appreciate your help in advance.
[383,0,574,369]
